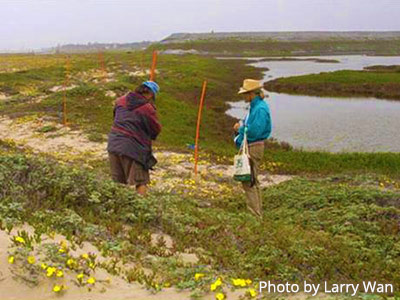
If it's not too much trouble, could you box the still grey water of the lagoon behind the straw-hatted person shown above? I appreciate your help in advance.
[227,56,400,152]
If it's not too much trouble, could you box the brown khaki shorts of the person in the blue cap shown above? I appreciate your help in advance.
[108,153,150,186]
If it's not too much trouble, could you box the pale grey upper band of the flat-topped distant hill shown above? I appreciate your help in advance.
[161,31,400,43]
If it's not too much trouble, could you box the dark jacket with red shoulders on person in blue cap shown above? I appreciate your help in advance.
[107,93,161,170]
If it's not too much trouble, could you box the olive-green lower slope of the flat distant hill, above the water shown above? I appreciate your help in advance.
[152,39,400,57]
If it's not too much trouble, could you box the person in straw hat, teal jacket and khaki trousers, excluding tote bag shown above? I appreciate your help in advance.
[233,79,272,218]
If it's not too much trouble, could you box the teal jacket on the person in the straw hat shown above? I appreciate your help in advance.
[235,96,272,147]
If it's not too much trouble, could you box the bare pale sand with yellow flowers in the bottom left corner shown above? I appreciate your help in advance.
[0,226,244,300]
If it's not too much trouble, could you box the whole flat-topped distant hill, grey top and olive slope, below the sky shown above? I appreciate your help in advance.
[152,31,400,57]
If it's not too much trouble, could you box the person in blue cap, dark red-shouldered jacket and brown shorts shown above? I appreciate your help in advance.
[107,81,161,195]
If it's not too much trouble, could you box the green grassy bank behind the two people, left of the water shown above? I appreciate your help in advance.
[0,52,262,154]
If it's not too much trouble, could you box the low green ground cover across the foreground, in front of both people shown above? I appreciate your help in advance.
[0,146,400,297]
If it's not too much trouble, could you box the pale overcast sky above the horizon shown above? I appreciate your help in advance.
[0,0,400,50]
